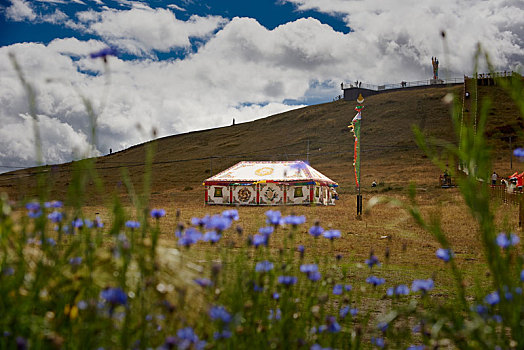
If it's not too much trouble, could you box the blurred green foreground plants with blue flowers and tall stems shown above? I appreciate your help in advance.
[0,50,524,349]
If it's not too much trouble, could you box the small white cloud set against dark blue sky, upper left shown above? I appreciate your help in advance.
[77,3,227,55]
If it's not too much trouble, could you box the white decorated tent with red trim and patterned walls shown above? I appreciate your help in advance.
[204,161,338,205]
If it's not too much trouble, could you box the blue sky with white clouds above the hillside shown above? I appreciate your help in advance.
[0,0,524,171]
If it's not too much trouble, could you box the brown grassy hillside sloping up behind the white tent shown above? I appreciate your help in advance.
[0,82,523,204]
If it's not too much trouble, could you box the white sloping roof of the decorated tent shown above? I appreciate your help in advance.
[204,161,337,186]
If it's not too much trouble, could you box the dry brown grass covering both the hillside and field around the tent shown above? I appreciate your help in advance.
[0,80,522,292]
